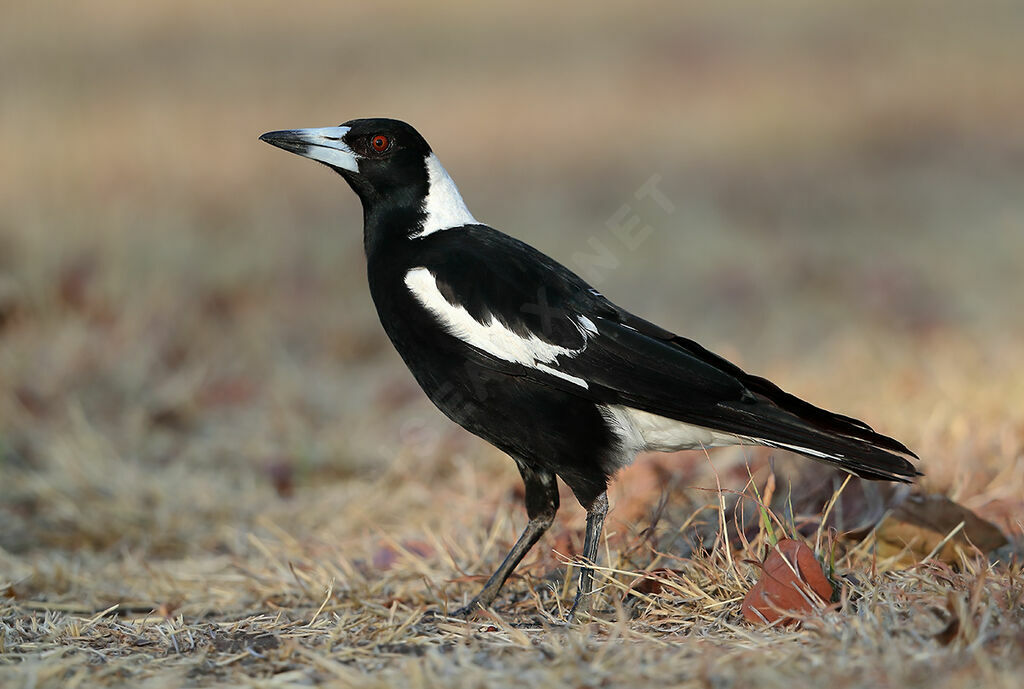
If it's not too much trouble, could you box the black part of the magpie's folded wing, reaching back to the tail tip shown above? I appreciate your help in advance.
[418,225,919,480]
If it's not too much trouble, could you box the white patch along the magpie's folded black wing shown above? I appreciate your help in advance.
[406,267,597,389]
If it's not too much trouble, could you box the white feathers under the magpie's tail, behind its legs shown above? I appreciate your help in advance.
[600,404,752,462]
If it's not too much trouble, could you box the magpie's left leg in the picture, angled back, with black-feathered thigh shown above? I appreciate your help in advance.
[452,462,558,617]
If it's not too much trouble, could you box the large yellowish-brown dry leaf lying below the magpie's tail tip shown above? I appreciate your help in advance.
[876,496,1007,566]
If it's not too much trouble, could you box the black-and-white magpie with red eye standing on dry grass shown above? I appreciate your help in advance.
[259,118,921,619]
